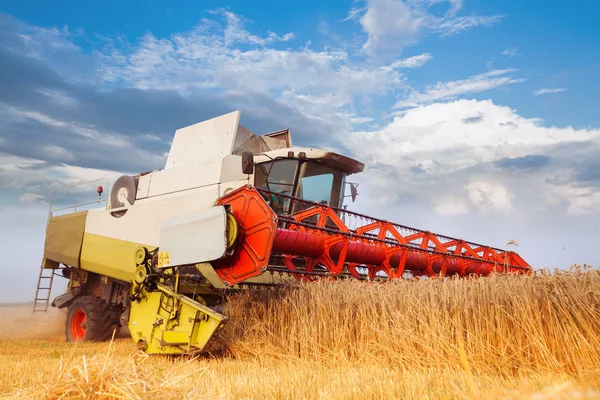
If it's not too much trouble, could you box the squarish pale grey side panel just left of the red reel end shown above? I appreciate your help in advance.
[160,206,227,267]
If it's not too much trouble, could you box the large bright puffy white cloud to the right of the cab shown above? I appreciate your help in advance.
[348,100,600,215]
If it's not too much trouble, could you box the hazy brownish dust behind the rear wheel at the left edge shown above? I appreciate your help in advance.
[0,305,66,339]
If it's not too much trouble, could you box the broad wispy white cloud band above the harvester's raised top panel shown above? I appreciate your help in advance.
[100,12,432,126]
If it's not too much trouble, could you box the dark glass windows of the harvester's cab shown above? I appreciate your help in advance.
[255,159,346,214]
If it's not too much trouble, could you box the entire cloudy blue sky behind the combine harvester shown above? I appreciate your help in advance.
[0,0,600,301]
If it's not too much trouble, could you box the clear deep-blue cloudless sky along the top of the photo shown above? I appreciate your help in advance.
[0,0,600,127]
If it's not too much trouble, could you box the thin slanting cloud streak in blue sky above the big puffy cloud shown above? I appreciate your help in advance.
[394,69,525,108]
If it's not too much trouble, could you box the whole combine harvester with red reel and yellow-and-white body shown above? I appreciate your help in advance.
[34,111,531,354]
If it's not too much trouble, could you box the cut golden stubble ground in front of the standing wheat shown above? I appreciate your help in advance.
[0,278,600,399]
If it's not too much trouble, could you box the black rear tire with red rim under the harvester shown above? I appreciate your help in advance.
[65,295,119,342]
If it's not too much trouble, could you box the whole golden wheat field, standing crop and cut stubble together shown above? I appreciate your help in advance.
[0,266,600,399]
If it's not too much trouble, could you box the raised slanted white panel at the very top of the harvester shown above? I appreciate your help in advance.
[165,111,240,169]
